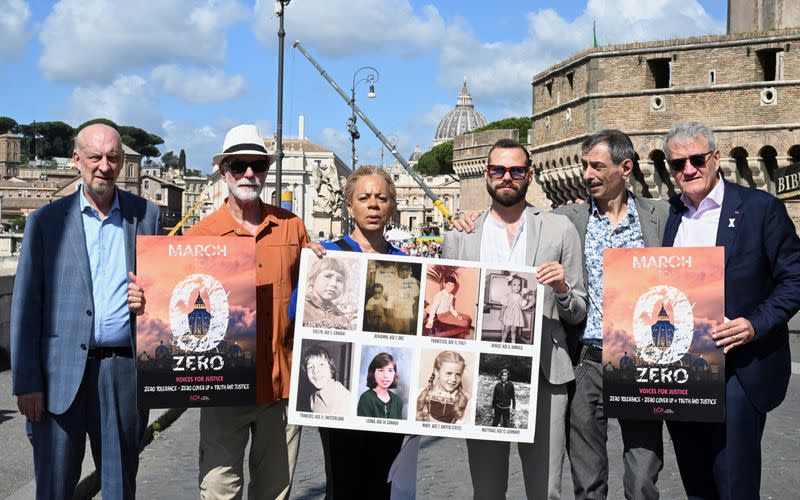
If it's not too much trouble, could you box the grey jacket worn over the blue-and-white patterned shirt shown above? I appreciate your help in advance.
[552,195,669,352]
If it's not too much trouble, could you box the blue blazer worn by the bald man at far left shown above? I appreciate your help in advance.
[11,189,162,414]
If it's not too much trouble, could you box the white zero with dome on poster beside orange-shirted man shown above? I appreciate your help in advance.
[169,274,228,352]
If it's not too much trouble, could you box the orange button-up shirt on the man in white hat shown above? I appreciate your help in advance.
[186,199,309,403]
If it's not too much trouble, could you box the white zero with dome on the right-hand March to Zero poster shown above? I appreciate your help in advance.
[633,285,694,365]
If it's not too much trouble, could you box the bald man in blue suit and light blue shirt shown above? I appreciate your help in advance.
[11,124,161,499]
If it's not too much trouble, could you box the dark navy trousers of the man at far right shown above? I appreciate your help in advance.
[667,375,764,500]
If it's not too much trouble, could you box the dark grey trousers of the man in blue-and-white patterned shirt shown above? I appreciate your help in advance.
[567,347,664,500]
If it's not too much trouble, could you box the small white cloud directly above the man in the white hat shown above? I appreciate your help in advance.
[150,64,245,102]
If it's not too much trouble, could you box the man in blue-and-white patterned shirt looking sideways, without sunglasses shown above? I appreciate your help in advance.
[553,129,669,500]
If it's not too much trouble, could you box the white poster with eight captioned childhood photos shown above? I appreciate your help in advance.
[289,250,545,442]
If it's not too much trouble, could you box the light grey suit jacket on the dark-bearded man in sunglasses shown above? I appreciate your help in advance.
[442,205,586,384]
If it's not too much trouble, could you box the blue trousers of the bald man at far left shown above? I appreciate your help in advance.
[27,357,147,500]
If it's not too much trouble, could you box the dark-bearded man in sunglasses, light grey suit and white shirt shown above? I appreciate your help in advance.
[442,139,586,500]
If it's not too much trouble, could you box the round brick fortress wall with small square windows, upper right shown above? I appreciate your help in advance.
[528,28,800,227]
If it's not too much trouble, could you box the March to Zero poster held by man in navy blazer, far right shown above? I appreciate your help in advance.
[603,247,725,422]
